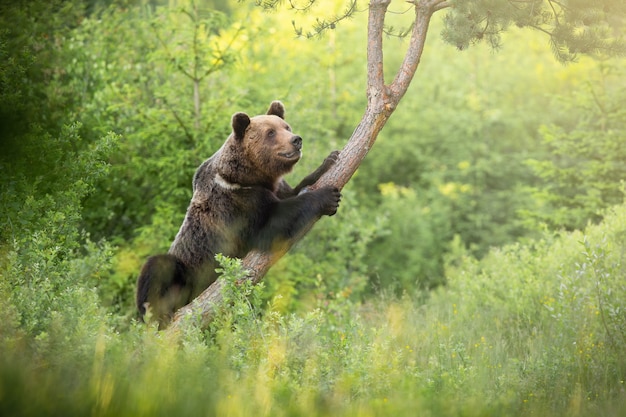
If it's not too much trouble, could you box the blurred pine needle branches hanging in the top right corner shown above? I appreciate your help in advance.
[442,0,626,61]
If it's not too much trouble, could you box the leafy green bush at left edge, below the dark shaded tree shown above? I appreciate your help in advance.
[0,124,116,334]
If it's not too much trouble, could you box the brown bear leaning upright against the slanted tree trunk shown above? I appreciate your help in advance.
[137,101,341,328]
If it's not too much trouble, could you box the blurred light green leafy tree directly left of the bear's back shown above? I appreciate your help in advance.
[70,1,242,240]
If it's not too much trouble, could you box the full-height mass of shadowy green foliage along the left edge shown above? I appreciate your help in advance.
[0,1,119,338]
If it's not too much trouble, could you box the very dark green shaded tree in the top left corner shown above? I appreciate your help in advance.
[0,0,84,187]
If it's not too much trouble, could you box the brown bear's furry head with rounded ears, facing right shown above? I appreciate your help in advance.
[230,101,302,184]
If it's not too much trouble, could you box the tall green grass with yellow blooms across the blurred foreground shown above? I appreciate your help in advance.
[0,207,626,416]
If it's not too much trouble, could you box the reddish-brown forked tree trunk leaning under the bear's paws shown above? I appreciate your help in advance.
[169,0,450,331]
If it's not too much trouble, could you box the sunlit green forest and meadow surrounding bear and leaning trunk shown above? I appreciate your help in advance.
[0,0,626,416]
